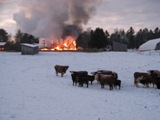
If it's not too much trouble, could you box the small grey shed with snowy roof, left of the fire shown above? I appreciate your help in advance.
[21,43,39,55]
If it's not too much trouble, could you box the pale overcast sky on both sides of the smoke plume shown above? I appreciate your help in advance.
[0,0,160,34]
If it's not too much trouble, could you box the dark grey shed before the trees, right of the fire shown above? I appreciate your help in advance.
[112,42,127,51]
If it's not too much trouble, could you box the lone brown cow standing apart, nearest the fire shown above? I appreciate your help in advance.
[54,65,69,77]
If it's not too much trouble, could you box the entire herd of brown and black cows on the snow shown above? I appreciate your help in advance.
[54,65,160,90]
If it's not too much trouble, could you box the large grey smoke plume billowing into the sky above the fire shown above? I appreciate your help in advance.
[13,0,101,39]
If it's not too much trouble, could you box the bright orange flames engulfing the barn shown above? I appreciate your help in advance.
[41,36,77,51]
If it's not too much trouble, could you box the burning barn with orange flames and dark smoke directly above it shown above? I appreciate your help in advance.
[39,25,80,51]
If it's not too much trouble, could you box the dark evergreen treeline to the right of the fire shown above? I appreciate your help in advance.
[77,27,160,49]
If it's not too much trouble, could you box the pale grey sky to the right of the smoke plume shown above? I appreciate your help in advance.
[87,0,160,31]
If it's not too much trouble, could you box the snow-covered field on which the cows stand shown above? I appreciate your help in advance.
[0,52,160,120]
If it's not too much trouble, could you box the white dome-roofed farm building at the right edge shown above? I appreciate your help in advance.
[139,38,160,51]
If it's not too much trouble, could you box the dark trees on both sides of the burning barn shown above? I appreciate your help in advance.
[0,27,160,51]
